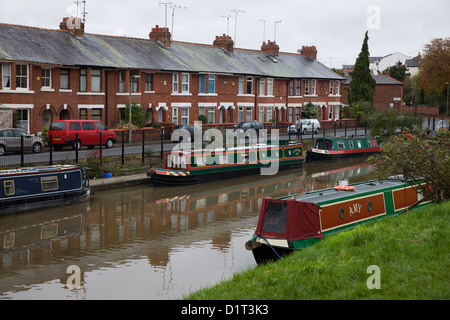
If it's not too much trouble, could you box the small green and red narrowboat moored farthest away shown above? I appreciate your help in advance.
[306,136,381,162]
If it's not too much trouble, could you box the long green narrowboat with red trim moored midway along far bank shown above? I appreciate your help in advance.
[147,140,305,185]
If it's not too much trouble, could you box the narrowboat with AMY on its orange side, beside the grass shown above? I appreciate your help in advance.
[245,179,429,264]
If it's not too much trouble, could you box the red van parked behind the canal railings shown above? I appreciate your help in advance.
[48,120,117,150]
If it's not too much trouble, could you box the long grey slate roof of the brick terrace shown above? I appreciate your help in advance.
[0,23,344,80]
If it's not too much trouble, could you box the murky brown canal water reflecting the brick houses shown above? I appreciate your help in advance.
[0,160,375,300]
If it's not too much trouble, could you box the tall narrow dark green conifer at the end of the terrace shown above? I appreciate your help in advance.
[348,31,375,105]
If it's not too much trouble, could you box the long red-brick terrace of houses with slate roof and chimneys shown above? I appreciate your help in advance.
[0,17,345,133]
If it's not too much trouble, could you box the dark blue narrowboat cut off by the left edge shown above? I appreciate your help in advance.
[0,165,90,214]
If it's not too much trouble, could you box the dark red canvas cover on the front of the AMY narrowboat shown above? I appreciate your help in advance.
[256,198,323,241]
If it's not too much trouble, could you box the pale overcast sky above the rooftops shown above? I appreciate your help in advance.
[0,0,450,67]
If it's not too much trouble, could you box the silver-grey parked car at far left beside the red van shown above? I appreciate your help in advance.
[0,128,44,156]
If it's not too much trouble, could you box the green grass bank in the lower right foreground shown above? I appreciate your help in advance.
[185,202,450,300]
